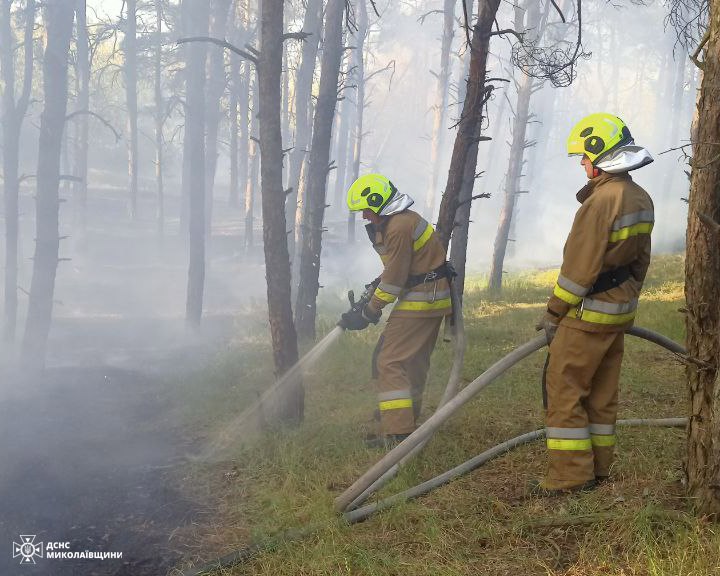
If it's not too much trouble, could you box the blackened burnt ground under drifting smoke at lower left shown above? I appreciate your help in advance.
[0,322,233,576]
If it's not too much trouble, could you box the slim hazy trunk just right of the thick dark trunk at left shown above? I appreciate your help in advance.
[73,0,90,244]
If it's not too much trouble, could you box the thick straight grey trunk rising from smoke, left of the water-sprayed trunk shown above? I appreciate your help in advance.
[183,0,208,329]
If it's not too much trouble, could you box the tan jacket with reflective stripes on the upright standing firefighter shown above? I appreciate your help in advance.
[548,172,655,332]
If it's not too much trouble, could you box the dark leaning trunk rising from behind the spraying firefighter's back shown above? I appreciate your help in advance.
[437,0,500,248]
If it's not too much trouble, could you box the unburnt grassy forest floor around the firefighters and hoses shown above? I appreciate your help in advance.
[175,255,720,576]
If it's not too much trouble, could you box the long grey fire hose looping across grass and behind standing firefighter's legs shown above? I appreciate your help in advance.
[182,327,687,576]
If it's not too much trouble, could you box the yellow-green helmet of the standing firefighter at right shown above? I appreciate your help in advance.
[567,112,633,165]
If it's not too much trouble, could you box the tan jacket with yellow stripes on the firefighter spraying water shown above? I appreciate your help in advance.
[365,210,452,318]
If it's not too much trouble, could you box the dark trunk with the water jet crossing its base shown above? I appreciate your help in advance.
[258,0,304,423]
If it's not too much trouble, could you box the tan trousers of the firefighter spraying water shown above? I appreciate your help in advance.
[373,315,443,434]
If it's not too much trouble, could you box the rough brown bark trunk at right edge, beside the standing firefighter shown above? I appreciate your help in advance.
[685,0,720,518]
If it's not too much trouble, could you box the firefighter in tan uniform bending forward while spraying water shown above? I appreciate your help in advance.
[339,174,452,445]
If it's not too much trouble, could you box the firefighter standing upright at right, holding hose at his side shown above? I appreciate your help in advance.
[532,113,654,495]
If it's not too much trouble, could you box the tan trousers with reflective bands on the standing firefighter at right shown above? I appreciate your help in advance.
[543,324,625,489]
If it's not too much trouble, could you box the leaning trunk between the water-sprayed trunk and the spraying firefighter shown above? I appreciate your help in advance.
[295,0,345,339]
